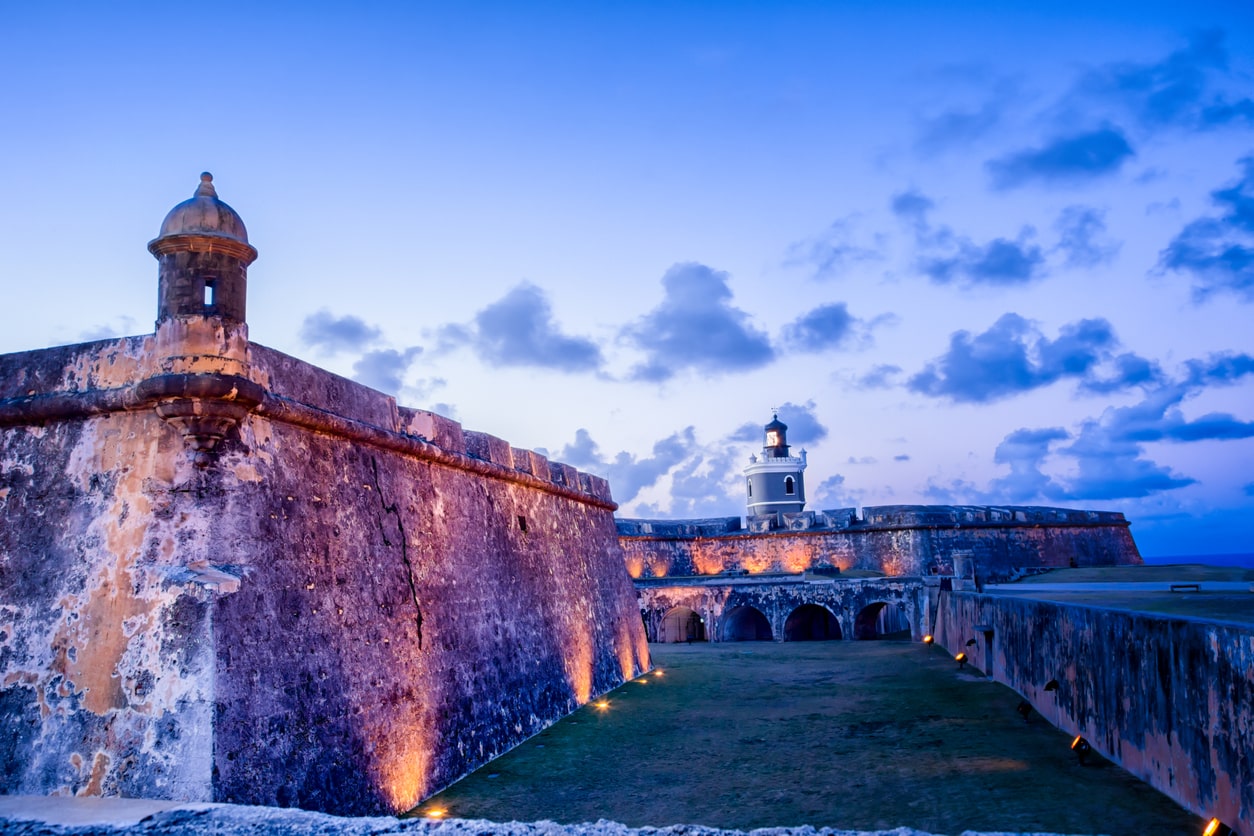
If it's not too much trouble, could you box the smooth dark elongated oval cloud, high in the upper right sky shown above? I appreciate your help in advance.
[984,127,1135,189]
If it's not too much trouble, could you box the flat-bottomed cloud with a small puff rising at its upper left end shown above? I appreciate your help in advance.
[890,189,1045,286]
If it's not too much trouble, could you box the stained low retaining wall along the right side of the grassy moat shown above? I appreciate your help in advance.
[934,593,1254,833]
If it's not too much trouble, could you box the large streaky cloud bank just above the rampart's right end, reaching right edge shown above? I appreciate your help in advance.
[989,355,1254,501]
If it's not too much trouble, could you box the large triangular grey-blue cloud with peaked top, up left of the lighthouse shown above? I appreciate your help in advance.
[623,262,775,381]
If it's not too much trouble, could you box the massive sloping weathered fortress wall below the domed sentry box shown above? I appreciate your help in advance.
[0,336,648,813]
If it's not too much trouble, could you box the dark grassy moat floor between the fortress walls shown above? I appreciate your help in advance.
[415,642,1203,836]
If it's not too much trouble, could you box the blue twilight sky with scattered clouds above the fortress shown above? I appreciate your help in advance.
[0,3,1254,555]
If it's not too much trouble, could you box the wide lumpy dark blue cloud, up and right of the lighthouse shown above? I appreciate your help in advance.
[907,313,1119,404]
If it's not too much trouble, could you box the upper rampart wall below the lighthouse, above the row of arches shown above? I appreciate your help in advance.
[617,505,1141,580]
